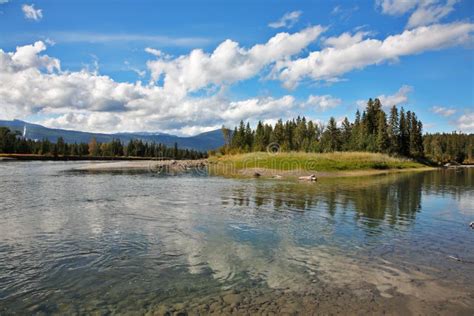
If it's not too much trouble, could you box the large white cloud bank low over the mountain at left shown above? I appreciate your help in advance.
[0,42,306,134]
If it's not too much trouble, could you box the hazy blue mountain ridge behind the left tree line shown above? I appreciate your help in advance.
[0,120,224,151]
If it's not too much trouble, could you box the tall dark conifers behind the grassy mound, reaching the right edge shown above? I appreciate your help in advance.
[221,99,474,162]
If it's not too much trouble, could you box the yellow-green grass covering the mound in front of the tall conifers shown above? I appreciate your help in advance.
[209,152,425,172]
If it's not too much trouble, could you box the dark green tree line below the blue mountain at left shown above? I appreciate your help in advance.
[0,127,207,159]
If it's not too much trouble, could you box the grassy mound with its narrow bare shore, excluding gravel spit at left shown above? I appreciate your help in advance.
[209,152,433,178]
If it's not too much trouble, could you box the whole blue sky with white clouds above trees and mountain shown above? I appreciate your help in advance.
[0,0,474,135]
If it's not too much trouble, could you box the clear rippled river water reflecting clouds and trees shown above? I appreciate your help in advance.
[0,162,474,315]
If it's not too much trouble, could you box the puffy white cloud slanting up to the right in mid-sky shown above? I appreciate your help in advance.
[147,26,325,95]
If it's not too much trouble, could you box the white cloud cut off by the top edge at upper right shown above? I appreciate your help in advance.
[376,0,459,28]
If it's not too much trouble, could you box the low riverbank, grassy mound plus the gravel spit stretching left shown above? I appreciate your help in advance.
[68,152,433,179]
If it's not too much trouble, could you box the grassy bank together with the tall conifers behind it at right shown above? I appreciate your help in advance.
[209,99,474,179]
